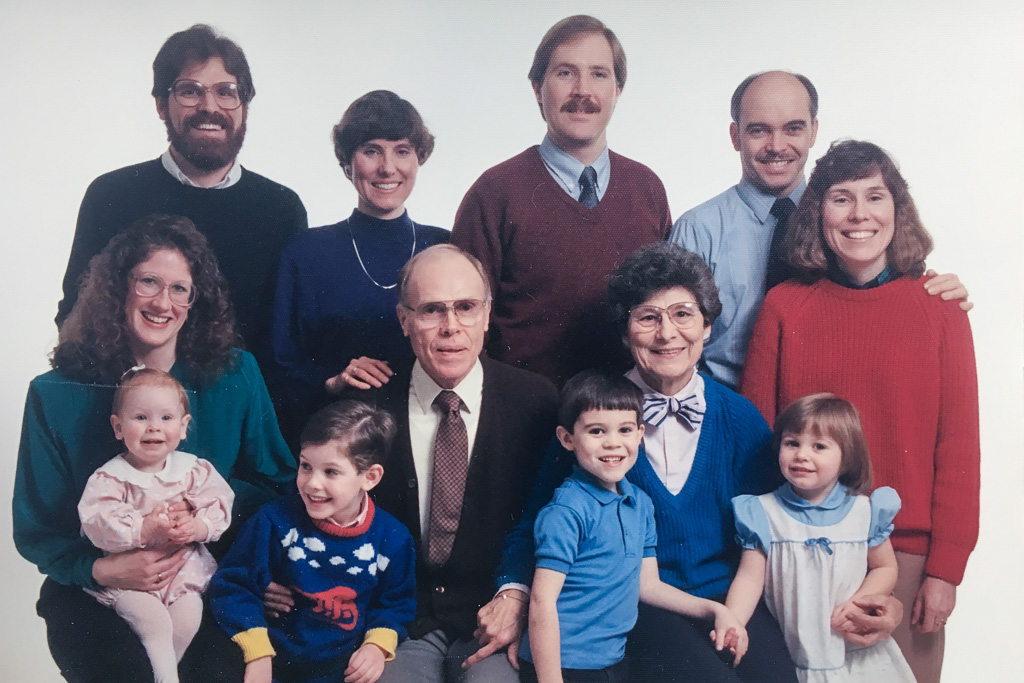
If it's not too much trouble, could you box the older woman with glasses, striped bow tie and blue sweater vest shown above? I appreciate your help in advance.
[483,243,898,682]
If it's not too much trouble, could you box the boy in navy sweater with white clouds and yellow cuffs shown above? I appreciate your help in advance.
[210,400,416,683]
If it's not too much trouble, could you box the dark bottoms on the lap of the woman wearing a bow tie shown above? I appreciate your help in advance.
[626,602,797,683]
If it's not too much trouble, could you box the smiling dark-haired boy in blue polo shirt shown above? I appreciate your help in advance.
[519,371,746,683]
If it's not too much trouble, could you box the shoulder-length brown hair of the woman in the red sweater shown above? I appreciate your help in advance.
[783,140,932,281]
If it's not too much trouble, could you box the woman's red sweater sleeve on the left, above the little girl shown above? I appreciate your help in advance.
[739,291,782,427]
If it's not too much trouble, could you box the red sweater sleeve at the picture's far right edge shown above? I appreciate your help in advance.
[925,302,981,584]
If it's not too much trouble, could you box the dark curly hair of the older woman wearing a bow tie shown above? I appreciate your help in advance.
[608,242,722,336]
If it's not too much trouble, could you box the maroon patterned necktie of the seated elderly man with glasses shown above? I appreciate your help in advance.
[427,389,469,566]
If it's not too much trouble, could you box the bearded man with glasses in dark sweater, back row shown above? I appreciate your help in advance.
[56,25,306,366]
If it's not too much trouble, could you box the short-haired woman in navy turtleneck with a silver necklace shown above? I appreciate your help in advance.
[270,90,449,445]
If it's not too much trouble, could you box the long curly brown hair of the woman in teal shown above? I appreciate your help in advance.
[56,214,239,384]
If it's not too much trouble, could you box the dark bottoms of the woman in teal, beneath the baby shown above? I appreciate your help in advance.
[36,579,245,683]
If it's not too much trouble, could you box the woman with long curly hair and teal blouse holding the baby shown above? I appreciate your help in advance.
[13,216,295,681]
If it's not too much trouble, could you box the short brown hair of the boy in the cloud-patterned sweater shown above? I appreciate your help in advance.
[299,400,397,472]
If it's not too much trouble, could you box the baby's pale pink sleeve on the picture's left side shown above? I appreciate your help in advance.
[78,472,142,553]
